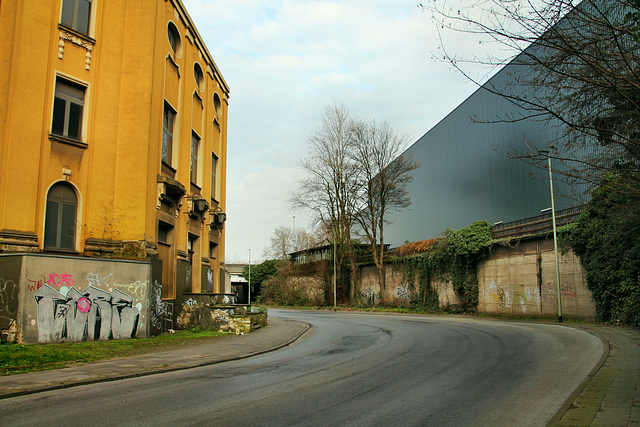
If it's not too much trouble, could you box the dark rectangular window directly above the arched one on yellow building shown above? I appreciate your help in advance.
[51,78,85,141]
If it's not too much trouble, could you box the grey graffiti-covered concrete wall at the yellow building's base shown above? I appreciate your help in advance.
[0,254,156,343]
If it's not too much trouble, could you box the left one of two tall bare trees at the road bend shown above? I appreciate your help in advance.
[290,103,357,297]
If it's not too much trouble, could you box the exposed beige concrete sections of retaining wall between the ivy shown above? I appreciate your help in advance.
[305,236,596,319]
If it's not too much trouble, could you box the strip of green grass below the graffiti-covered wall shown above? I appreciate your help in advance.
[0,331,229,375]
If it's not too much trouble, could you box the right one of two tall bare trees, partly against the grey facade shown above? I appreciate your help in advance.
[350,121,417,299]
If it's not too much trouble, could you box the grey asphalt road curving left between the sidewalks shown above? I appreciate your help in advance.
[0,310,603,426]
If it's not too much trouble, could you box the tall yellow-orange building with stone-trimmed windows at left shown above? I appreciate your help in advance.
[0,0,229,299]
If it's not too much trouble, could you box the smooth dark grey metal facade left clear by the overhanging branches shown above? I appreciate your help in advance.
[385,64,578,247]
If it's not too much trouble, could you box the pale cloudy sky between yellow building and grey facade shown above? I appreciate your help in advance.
[183,0,492,264]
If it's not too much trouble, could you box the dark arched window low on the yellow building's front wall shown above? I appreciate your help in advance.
[44,182,78,250]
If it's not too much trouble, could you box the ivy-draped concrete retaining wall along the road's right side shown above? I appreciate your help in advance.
[355,229,596,319]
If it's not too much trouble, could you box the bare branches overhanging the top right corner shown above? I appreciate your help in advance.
[420,0,640,196]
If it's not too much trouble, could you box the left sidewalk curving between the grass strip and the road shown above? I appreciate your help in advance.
[0,317,310,399]
